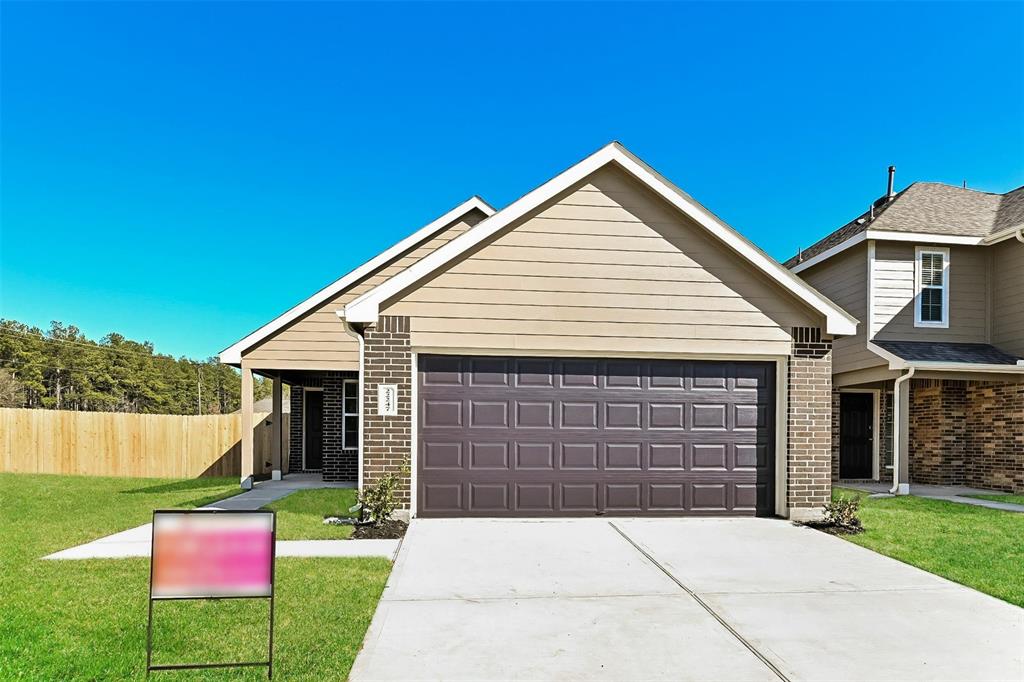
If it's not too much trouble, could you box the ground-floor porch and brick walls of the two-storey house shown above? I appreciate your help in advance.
[831,372,1024,497]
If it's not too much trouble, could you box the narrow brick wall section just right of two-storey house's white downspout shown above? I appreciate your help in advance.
[908,379,967,485]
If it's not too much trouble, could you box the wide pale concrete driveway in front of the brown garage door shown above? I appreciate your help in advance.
[351,518,1024,681]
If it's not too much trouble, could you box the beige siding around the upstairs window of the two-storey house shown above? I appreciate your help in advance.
[873,242,988,343]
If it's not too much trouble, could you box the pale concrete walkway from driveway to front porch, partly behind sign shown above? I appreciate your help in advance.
[43,474,399,559]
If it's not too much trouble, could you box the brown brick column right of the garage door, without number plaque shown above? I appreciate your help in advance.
[786,327,834,517]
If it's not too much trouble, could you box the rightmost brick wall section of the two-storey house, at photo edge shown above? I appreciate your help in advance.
[964,382,1024,493]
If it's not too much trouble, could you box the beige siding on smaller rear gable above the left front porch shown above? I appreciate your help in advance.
[242,210,486,371]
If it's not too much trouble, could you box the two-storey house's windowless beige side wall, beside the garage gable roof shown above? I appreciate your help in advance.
[800,244,884,374]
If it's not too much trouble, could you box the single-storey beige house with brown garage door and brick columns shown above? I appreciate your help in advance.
[221,142,857,518]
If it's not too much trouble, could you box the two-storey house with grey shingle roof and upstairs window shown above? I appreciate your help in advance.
[785,168,1024,493]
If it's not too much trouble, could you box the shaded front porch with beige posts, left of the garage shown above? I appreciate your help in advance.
[242,367,360,489]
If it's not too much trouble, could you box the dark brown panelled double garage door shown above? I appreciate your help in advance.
[417,355,775,516]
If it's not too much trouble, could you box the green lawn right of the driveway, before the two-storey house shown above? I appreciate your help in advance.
[833,488,1024,606]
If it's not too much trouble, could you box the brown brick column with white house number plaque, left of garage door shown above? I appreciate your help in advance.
[362,315,413,509]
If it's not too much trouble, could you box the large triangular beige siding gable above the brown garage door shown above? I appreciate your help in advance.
[382,168,821,354]
